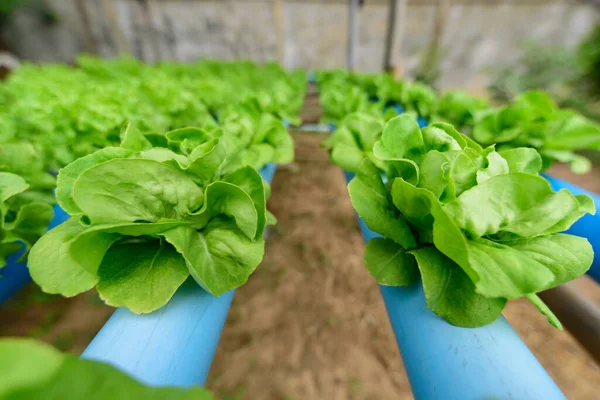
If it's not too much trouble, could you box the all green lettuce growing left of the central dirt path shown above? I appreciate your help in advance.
[0,56,306,399]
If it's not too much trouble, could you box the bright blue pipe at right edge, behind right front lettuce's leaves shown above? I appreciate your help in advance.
[544,175,600,282]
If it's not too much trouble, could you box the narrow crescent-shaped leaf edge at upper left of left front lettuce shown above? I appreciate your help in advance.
[56,147,132,215]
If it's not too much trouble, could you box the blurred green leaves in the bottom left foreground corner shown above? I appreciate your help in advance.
[0,338,214,400]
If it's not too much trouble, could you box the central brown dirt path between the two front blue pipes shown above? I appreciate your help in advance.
[210,135,410,400]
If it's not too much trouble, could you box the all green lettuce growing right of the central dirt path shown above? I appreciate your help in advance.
[318,72,600,329]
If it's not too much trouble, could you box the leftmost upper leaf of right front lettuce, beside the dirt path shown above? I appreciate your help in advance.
[348,160,417,249]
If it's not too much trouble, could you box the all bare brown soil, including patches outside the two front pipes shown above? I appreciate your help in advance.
[0,92,600,400]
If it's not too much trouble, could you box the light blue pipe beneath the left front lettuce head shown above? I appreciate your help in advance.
[82,164,275,386]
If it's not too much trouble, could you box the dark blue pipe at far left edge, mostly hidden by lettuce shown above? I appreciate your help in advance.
[0,204,69,304]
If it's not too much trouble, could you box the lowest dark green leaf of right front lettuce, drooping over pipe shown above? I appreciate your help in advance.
[410,247,506,328]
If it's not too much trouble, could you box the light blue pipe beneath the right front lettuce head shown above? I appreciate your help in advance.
[345,173,565,400]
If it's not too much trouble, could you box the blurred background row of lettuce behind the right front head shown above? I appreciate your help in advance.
[316,71,600,173]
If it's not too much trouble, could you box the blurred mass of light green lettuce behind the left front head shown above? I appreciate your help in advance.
[0,56,306,170]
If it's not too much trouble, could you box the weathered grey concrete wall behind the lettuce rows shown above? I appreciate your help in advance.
[5,0,598,87]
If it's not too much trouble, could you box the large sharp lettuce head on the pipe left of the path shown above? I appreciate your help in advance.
[28,126,269,313]
